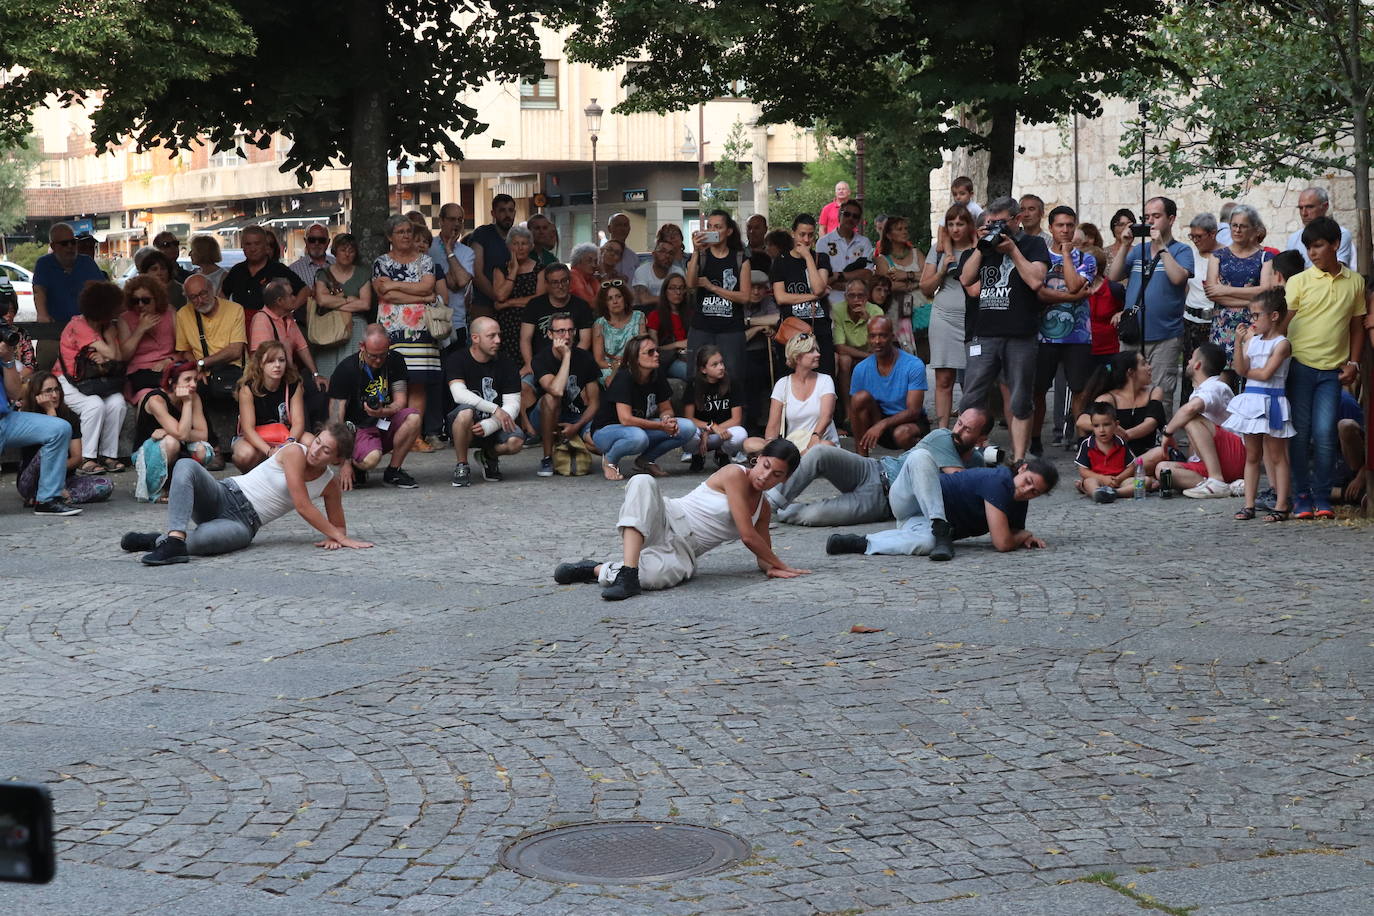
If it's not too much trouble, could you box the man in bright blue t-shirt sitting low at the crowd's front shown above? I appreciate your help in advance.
[849,317,930,457]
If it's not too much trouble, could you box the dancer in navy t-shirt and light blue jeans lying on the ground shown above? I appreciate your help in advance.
[826,452,1059,560]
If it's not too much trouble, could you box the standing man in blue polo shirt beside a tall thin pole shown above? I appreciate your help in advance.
[1107,198,1194,413]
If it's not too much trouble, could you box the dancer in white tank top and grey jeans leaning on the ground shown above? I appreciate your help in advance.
[120,422,372,566]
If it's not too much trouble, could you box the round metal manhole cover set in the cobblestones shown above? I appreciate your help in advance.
[500,821,749,884]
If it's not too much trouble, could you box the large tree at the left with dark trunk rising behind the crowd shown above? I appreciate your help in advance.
[0,0,573,255]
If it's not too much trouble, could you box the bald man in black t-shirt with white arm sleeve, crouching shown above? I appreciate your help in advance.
[444,317,525,486]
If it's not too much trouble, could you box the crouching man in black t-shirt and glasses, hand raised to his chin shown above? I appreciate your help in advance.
[534,312,600,477]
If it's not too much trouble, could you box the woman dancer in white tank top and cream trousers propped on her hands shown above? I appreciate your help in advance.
[554,439,811,602]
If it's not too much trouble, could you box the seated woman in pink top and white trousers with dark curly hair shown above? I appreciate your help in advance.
[52,282,129,474]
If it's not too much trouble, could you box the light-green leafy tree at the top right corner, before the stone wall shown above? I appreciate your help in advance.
[1116,0,1374,271]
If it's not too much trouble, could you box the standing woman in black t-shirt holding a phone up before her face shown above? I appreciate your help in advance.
[687,210,753,385]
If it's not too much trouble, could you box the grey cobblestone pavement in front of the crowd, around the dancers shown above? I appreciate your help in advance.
[0,439,1374,916]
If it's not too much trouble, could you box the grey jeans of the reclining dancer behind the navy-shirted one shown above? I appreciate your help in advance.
[768,445,892,527]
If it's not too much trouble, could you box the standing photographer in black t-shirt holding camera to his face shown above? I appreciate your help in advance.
[959,198,1050,463]
